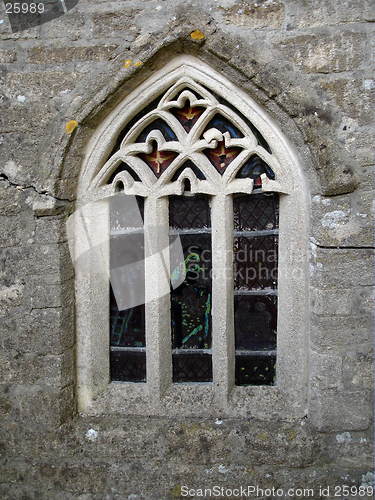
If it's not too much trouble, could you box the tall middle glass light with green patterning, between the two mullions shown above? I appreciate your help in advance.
[169,196,212,382]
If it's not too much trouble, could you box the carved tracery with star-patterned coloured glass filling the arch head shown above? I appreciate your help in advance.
[96,77,286,196]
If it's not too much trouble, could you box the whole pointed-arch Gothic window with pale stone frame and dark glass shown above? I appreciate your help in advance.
[72,57,306,413]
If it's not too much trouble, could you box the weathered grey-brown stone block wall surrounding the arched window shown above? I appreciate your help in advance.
[0,0,375,500]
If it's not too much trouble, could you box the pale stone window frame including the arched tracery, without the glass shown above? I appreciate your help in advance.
[76,55,308,417]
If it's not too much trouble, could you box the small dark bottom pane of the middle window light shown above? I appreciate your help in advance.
[172,353,212,382]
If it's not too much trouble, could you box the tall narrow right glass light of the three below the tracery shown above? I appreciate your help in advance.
[233,193,278,385]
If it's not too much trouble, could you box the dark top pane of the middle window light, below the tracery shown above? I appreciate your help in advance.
[169,196,211,229]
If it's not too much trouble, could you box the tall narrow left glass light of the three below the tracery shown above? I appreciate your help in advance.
[110,194,146,382]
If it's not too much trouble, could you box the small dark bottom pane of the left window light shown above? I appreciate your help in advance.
[110,351,146,382]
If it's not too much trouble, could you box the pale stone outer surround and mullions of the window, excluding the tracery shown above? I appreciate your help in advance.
[75,55,309,418]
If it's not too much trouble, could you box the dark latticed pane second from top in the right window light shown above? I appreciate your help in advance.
[234,236,277,290]
